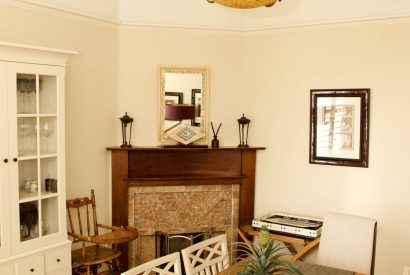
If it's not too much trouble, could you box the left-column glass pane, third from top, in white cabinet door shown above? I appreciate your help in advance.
[18,160,38,200]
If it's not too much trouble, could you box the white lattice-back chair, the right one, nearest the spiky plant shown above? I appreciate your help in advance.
[181,234,229,275]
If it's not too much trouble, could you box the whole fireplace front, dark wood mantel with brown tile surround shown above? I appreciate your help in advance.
[108,147,264,270]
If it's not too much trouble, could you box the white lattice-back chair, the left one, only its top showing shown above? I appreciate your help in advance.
[121,252,182,275]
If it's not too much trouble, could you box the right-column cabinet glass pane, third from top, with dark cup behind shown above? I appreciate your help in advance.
[40,157,58,196]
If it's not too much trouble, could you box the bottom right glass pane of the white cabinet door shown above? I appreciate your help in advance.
[41,197,59,236]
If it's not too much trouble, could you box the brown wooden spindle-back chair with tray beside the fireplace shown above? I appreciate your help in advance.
[66,190,138,275]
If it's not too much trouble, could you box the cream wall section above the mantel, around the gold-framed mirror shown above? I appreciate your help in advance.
[115,29,243,146]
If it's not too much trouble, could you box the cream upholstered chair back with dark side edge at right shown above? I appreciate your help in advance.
[317,213,377,275]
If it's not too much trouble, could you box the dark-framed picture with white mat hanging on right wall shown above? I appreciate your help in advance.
[309,88,370,167]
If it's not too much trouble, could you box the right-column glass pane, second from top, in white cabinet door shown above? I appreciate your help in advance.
[40,117,57,155]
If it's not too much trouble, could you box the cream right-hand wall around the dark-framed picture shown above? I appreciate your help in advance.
[243,24,410,275]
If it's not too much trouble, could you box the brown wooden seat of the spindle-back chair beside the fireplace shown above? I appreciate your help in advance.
[71,245,121,267]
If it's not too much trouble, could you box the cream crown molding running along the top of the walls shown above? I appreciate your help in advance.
[0,0,410,36]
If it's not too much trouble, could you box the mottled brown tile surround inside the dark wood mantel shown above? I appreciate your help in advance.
[128,184,239,266]
